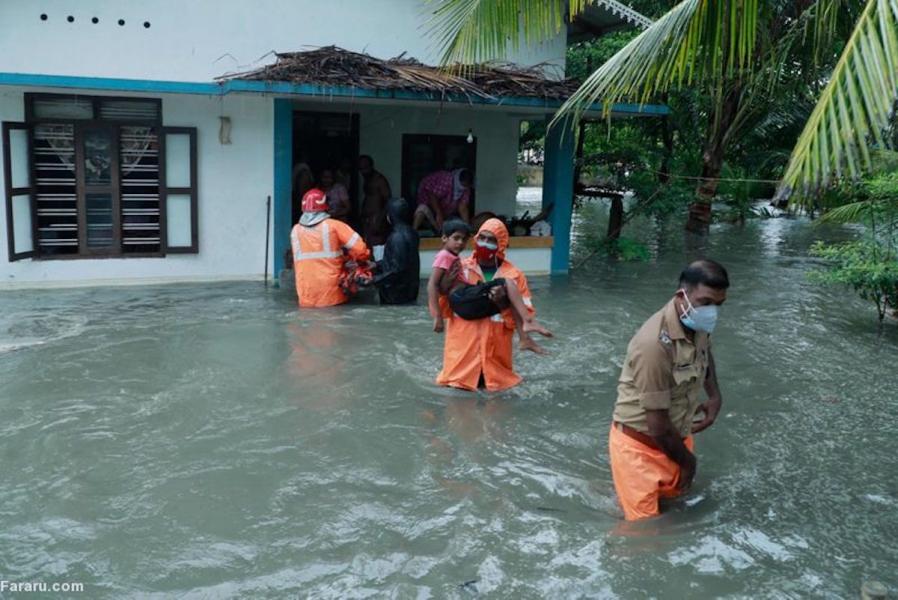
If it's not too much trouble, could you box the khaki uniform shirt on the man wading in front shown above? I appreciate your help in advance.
[614,300,711,437]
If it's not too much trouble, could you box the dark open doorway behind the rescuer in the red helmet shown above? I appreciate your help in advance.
[291,111,360,227]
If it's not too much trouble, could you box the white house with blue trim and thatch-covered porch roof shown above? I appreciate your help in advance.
[0,0,665,287]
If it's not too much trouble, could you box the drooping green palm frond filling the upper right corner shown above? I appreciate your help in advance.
[778,0,898,202]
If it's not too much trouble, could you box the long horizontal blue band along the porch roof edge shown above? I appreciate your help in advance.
[0,73,670,115]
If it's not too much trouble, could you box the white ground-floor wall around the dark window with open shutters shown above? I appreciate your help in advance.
[0,88,274,286]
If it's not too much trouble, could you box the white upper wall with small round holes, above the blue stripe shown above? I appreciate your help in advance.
[0,0,566,82]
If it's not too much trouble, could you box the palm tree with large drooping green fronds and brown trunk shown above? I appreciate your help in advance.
[433,0,898,230]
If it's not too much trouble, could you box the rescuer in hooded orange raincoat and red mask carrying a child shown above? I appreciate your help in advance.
[436,219,543,391]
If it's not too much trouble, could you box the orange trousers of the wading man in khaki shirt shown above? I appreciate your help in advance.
[608,424,693,521]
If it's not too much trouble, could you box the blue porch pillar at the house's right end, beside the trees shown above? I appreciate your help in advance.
[543,117,574,275]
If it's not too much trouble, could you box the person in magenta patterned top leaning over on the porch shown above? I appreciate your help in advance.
[412,169,474,233]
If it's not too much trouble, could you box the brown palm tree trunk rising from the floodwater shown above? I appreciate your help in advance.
[686,85,741,233]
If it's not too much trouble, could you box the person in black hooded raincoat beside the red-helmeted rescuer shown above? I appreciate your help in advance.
[374,198,421,304]
